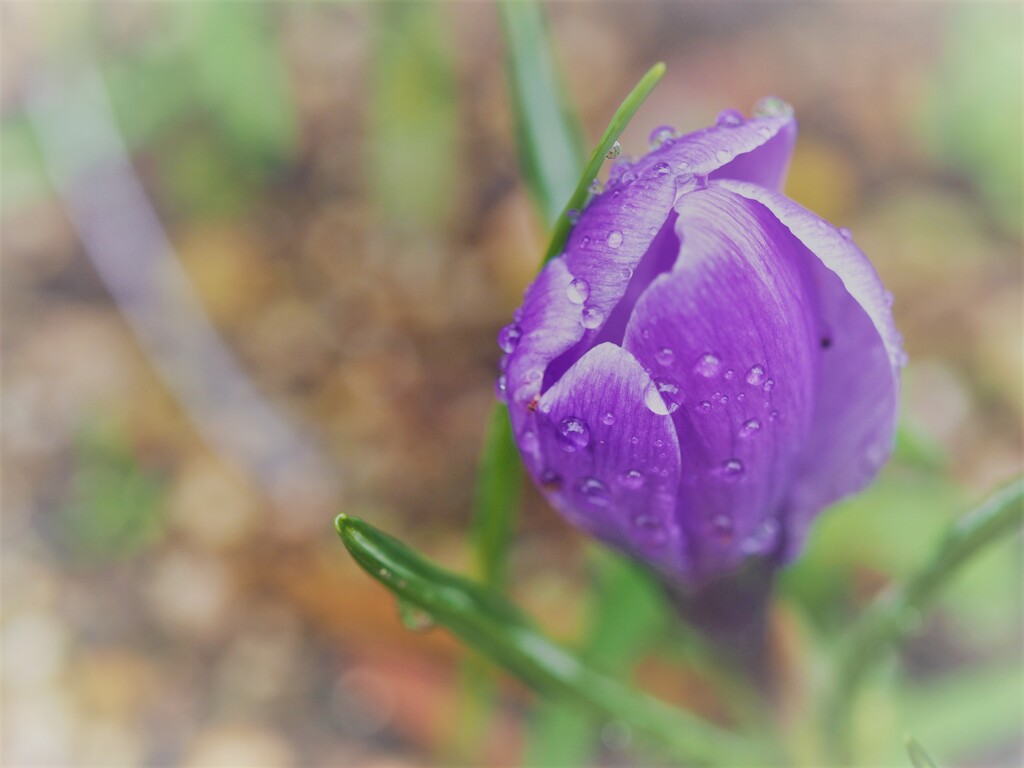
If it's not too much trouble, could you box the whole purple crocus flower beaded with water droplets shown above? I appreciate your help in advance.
[498,98,904,606]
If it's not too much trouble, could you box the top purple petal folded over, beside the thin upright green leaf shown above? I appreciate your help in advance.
[548,110,797,382]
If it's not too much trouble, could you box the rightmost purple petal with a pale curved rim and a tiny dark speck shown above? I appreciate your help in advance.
[722,182,905,557]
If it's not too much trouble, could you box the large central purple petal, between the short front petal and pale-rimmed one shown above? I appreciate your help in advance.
[624,185,820,578]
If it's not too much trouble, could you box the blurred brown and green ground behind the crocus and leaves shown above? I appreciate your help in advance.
[0,2,1024,766]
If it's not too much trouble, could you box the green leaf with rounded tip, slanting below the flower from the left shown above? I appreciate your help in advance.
[335,515,779,766]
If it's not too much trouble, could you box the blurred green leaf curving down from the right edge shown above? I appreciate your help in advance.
[825,477,1024,761]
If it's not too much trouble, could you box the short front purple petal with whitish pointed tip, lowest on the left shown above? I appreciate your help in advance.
[520,344,686,579]
